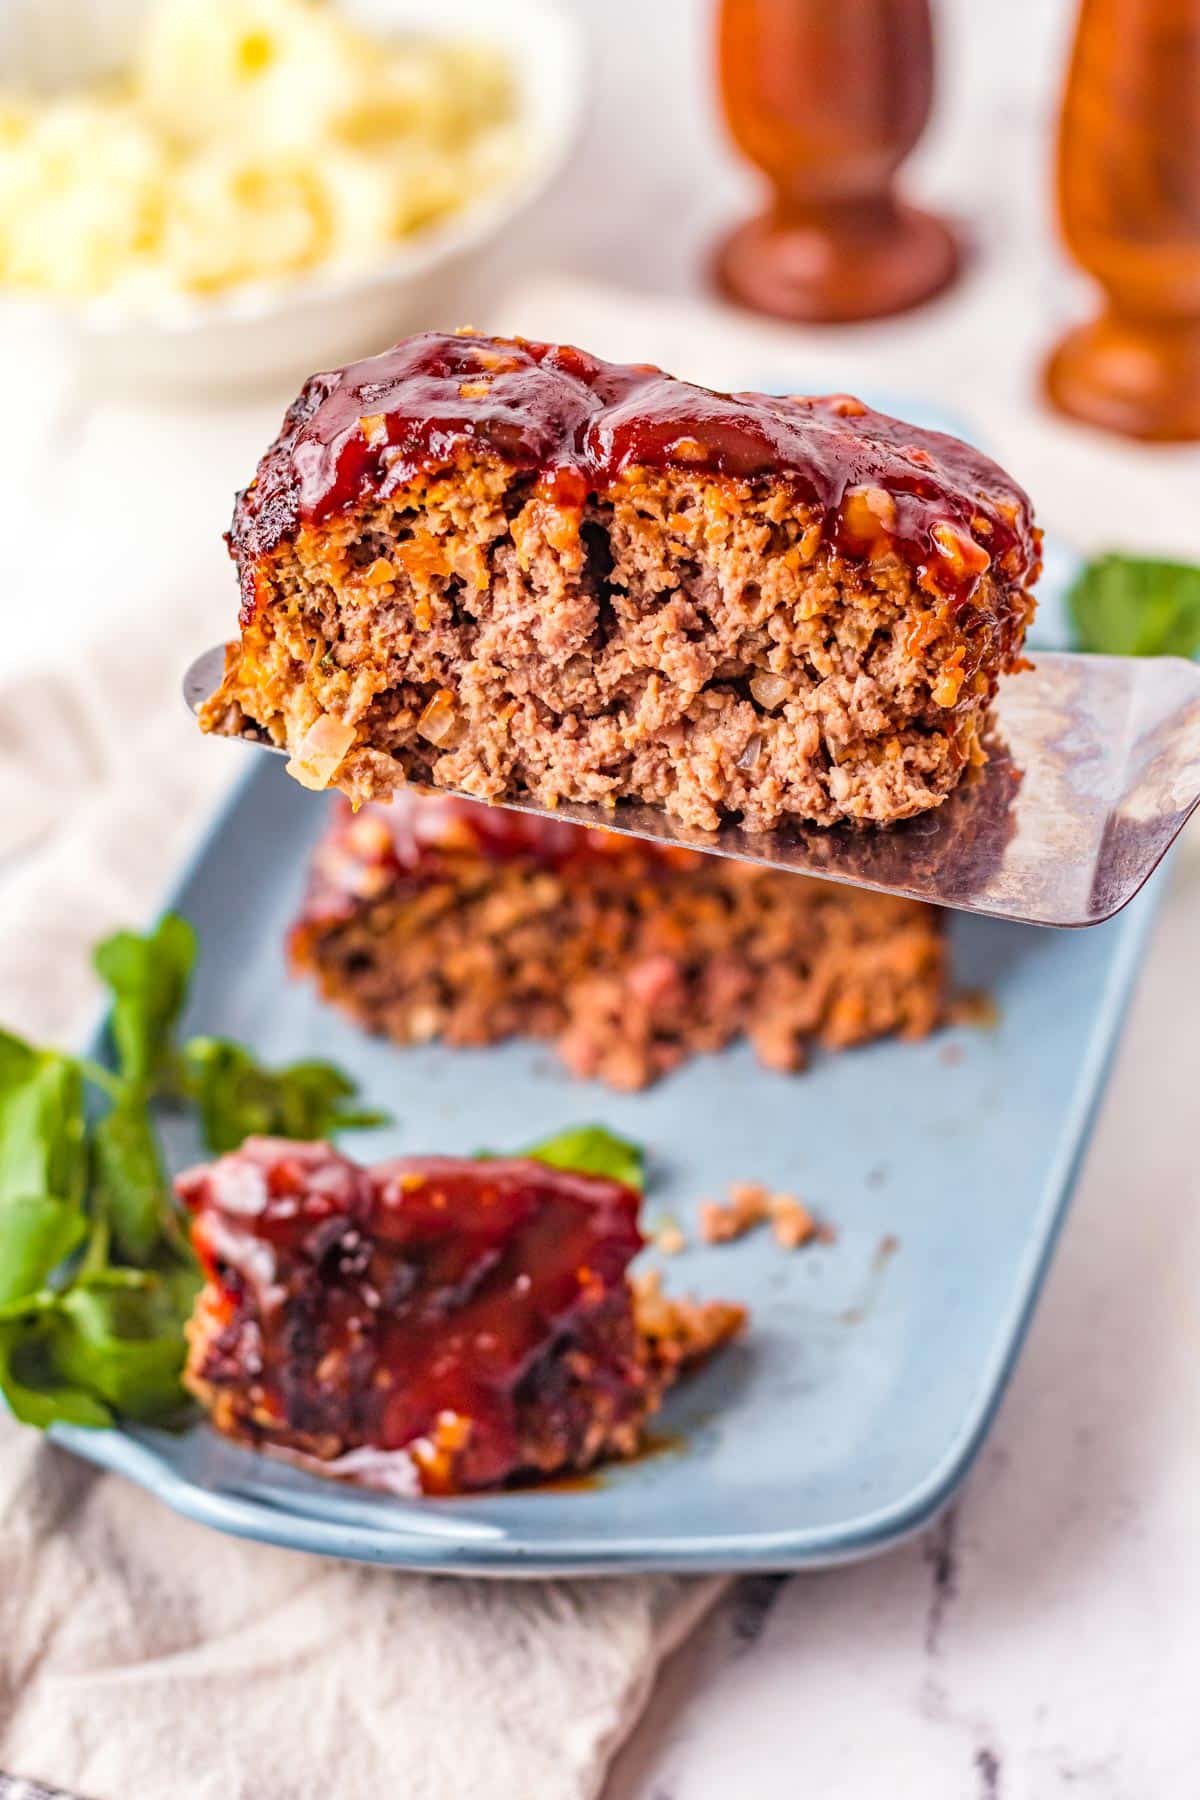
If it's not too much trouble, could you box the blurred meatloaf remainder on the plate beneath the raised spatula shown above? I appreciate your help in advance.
[290,788,946,1089]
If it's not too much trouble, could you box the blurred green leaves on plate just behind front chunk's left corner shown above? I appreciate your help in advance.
[184,1037,387,1150]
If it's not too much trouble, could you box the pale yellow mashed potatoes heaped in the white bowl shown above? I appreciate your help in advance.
[0,0,522,304]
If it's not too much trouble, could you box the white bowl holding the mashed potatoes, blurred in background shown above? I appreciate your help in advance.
[0,0,583,391]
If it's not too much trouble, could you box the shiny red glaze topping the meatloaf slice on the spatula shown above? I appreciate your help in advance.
[230,331,1038,623]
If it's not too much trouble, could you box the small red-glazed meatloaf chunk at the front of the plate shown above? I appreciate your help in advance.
[176,1138,743,1492]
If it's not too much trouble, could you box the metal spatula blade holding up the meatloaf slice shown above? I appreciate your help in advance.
[184,646,1200,925]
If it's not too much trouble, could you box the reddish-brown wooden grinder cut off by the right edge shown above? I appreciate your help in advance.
[1045,0,1200,441]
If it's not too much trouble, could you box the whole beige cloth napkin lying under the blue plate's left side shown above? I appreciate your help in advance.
[0,408,720,1800]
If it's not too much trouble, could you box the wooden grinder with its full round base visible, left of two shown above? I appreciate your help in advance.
[716,0,959,320]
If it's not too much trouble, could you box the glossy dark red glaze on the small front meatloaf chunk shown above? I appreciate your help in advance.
[176,1138,642,1487]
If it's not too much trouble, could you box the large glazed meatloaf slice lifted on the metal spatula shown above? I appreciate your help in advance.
[201,333,1040,830]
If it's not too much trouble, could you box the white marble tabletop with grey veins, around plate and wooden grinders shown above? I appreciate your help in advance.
[521,0,1200,1800]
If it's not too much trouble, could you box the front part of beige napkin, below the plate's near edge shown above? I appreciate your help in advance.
[0,1422,714,1800]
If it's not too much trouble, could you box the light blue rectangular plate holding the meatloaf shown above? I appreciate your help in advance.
[56,752,1157,1575]
